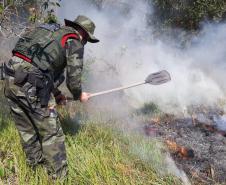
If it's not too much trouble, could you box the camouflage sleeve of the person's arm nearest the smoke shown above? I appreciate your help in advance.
[66,39,84,100]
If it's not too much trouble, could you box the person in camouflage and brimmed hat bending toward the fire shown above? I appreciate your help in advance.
[4,15,99,179]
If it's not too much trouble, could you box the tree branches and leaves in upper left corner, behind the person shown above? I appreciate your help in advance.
[0,0,60,38]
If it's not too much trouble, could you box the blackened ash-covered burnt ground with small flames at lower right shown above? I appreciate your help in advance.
[144,108,226,185]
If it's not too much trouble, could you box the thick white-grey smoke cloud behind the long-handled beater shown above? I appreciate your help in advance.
[58,0,226,183]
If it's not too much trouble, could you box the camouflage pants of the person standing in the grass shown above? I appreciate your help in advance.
[5,77,67,179]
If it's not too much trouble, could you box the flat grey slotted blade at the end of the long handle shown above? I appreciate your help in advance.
[145,70,171,85]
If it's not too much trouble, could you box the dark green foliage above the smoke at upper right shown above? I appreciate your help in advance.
[149,0,226,30]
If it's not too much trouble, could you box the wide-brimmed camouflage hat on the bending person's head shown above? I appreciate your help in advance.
[64,15,99,43]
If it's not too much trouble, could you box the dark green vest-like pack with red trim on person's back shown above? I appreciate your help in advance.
[13,23,79,72]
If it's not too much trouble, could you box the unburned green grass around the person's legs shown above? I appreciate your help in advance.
[0,110,179,185]
